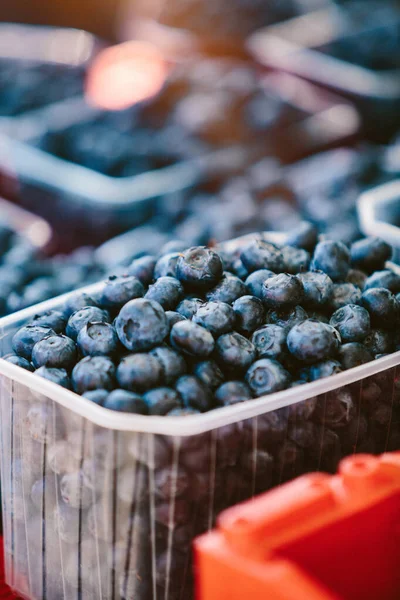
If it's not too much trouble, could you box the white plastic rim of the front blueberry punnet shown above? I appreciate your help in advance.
[0,284,400,437]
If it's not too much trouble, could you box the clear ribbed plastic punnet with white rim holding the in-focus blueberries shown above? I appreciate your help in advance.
[0,286,400,600]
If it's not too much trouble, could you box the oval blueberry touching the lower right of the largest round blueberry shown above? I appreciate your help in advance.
[170,320,214,356]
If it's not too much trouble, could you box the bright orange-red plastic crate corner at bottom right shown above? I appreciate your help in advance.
[195,452,400,600]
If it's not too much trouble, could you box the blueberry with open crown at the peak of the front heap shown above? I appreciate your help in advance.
[176,246,222,290]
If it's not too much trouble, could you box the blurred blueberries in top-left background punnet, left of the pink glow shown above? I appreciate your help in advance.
[0,59,85,117]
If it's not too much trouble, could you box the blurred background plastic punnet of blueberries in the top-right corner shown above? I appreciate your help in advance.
[248,2,400,142]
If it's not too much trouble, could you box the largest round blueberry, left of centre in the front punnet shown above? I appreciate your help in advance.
[115,298,169,352]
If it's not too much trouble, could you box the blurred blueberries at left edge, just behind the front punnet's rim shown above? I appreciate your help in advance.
[0,221,104,316]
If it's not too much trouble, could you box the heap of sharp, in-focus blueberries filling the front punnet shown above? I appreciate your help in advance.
[5,234,400,416]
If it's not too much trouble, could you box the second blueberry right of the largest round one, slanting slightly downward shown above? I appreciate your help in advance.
[215,331,256,372]
